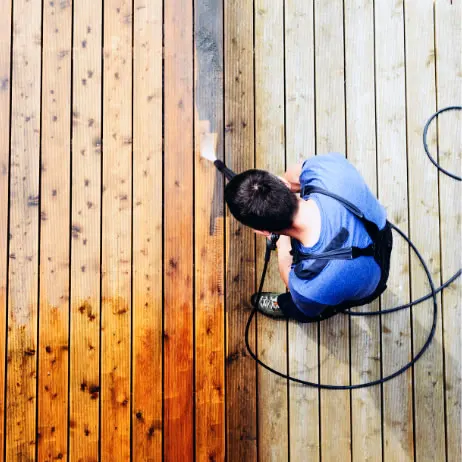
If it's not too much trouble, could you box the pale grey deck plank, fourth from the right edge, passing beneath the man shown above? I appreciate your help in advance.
[344,0,382,460]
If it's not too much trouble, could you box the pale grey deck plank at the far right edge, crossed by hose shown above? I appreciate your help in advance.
[432,1,462,462]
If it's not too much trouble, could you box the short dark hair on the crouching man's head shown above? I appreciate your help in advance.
[225,170,298,232]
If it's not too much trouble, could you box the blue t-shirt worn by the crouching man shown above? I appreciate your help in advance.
[289,153,386,316]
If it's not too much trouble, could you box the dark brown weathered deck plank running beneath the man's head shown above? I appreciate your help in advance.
[224,0,257,462]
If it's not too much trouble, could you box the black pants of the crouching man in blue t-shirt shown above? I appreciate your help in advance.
[278,221,393,323]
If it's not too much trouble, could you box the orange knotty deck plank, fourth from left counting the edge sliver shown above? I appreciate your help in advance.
[69,0,102,461]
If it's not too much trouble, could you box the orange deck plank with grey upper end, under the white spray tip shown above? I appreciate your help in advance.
[194,0,225,461]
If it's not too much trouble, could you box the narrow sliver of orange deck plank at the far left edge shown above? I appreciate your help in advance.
[0,0,12,454]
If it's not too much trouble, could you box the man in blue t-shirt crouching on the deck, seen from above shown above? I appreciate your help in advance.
[225,154,392,322]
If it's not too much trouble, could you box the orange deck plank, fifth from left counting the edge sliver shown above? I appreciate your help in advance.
[101,0,133,460]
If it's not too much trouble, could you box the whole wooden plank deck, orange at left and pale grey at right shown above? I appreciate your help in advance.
[0,0,462,462]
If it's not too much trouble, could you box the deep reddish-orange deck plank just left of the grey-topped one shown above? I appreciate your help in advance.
[164,0,195,462]
